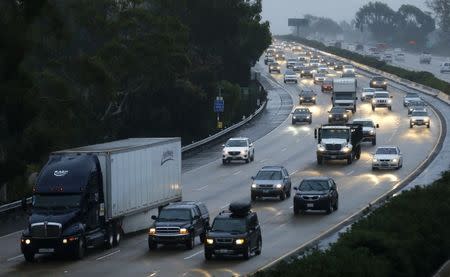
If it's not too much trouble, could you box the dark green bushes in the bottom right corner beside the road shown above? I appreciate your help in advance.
[255,171,450,277]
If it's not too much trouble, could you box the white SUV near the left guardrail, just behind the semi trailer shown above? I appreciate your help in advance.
[222,138,255,164]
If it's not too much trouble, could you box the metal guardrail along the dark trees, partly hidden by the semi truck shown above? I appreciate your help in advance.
[0,78,267,214]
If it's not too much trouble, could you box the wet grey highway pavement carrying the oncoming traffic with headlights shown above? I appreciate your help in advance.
[0,48,440,277]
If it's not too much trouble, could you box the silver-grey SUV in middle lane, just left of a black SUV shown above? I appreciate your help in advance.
[251,166,292,201]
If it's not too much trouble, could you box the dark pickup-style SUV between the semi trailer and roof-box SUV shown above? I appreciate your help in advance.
[148,201,209,250]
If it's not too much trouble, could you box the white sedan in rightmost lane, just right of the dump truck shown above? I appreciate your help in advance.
[372,146,403,170]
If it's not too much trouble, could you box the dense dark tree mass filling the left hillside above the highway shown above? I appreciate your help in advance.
[0,0,271,199]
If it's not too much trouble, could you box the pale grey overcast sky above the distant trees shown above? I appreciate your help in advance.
[262,0,428,34]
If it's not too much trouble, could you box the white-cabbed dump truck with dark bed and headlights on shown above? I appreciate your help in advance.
[314,124,363,165]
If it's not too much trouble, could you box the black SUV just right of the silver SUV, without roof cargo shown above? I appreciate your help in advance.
[294,177,339,214]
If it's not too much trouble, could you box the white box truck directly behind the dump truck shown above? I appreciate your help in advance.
[331,78,358,113]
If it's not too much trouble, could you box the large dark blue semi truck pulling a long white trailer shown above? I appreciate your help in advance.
[20,138,182,262]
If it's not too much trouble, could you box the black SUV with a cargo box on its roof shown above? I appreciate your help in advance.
[205,202,262,260]
